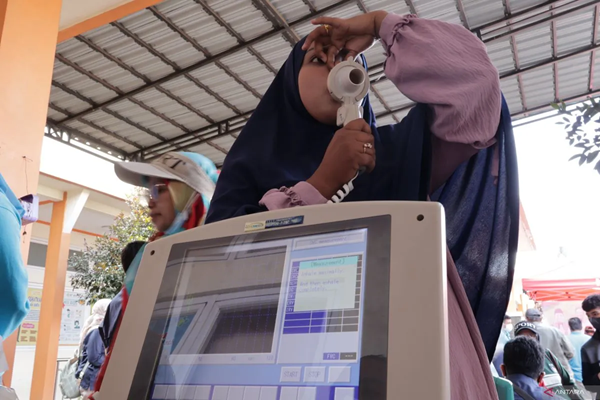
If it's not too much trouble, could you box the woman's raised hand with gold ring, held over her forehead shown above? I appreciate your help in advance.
[302,11,387,68]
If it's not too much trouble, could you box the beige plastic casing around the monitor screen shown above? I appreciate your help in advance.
[99,202,450,400]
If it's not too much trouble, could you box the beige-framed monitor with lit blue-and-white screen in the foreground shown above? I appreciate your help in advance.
[100,202,450,400]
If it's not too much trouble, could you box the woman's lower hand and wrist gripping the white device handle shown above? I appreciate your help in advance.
[307,119,376,199]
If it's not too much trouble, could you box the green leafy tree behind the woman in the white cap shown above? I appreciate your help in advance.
[68,190,154,304]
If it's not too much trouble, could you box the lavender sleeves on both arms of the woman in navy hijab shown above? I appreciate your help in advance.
[260,14,502,210]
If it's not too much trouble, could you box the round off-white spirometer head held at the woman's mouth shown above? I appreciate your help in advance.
[327,61,370,126]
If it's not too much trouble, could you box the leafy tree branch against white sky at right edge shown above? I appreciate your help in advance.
[552,99,600,173]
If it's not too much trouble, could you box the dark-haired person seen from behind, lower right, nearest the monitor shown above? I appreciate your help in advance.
[501,336,555,400]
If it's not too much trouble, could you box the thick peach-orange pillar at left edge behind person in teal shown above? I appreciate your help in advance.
[0,0,61,386]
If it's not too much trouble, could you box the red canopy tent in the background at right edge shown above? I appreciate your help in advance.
[523,278,600,301]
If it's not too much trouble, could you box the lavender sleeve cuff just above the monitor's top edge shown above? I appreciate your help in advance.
[260,182,327,211]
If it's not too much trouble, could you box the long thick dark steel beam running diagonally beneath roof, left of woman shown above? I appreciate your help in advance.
[54,0,355,126]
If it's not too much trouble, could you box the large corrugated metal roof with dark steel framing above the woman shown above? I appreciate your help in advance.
[45,0,600,166]
